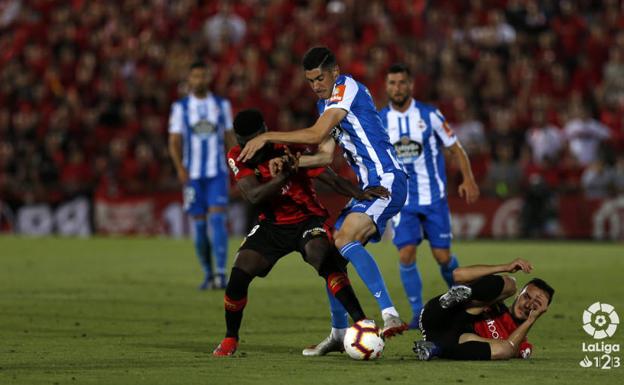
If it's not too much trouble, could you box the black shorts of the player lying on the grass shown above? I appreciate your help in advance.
[420,296,491,360]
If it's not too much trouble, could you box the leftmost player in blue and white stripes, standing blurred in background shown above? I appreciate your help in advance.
[169,62,235,290]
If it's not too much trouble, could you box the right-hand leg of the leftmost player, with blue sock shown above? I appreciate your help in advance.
[207,175,228,289]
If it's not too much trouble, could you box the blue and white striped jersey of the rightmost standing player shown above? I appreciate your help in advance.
[379,100,457,206]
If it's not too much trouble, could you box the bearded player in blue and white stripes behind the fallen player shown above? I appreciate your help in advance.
[380,64,479,329]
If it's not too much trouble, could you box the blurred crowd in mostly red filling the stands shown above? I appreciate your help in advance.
[0,0,624,210]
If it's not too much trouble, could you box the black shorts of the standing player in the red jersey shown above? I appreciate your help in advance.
[239,217,347,277]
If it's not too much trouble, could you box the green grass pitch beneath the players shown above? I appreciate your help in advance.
[0,237,624,385]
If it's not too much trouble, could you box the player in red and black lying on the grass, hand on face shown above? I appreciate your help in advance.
[414,258,555,360]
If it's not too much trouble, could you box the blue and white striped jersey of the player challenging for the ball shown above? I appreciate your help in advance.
[317,75,405,187]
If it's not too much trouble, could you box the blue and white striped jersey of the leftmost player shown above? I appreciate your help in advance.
[169,94,232,179]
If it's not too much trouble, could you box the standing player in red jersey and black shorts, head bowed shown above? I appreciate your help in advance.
[213,110,389,356]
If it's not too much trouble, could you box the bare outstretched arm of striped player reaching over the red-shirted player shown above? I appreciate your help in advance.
[237,108,347,162]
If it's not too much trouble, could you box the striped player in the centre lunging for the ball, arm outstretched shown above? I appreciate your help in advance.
[239,47,407,344]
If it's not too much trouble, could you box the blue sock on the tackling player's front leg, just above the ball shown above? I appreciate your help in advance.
[340,241,394,310]
